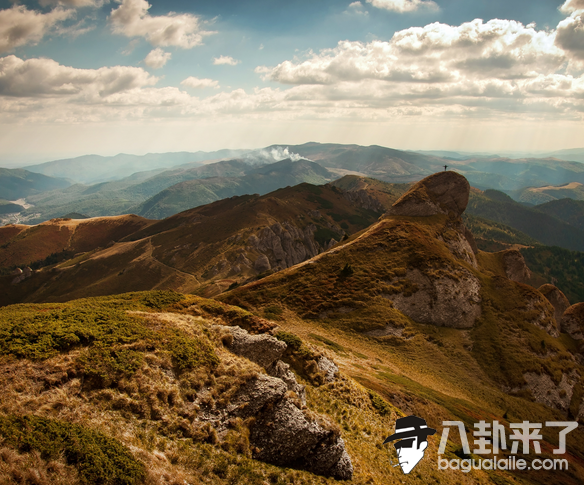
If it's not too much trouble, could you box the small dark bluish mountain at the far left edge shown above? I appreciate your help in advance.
[0,168,71,200]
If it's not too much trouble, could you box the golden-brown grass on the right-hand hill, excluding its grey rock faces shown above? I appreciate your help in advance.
[220,217,584,483]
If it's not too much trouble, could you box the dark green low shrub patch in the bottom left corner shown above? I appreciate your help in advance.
[0,415,145,485]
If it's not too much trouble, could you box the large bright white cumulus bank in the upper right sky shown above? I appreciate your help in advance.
[256,19,566,84]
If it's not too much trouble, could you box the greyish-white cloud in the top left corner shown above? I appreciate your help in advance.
[0,5,75,52]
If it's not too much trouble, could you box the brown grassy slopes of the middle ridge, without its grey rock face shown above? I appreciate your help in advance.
[0,184,379,304]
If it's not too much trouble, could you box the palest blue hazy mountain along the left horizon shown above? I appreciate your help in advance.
[24,150,247,183]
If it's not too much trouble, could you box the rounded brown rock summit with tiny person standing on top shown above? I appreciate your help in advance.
[388,172,470,217]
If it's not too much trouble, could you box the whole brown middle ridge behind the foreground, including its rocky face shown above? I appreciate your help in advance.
[0,184,382,304]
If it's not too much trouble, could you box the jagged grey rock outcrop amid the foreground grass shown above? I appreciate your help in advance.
[216,326,353,480]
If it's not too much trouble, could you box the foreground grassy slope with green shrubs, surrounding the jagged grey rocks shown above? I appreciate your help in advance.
[0,292,490,485]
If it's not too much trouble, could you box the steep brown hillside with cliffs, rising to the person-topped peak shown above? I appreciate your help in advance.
[218,174,584,484]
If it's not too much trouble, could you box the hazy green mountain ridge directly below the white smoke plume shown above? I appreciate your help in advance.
[132,159,335,219]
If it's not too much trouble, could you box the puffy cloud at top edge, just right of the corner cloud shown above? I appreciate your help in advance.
[109,0,214,49]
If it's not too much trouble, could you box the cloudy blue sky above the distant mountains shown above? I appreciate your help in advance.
[0,0,584,166]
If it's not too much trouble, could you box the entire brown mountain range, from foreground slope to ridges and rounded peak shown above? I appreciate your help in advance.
[0,171,584,485]
